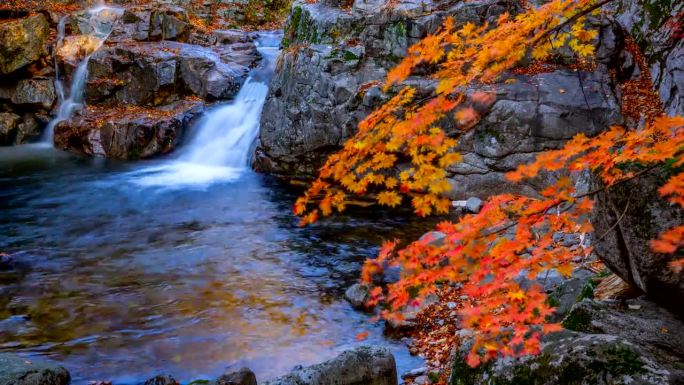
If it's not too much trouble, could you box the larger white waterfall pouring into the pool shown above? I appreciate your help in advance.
[134,33,280,187]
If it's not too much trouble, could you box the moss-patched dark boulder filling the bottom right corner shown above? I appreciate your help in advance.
[450,331,679,385]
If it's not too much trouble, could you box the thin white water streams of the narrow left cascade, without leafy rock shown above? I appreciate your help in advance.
[42,1,123,145]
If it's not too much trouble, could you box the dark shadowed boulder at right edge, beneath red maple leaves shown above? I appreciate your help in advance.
[591,170,684,313]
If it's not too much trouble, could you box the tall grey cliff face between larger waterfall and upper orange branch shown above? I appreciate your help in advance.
[255,0,520,176]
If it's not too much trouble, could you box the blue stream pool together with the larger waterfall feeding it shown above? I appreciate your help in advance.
[0,35,426,384]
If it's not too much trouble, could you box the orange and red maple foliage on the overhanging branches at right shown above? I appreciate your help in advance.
[294,0,684,366]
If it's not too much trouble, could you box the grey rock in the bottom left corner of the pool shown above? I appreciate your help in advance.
[0,353,71,385]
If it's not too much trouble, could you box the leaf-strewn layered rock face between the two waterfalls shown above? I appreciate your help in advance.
[48,4,259,159]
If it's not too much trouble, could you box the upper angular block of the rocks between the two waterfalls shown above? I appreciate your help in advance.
[85,41,258,106]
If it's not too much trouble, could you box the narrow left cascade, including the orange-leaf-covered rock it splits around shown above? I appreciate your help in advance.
[43,1,123,145]
